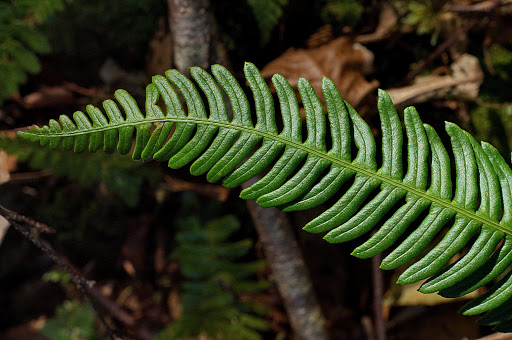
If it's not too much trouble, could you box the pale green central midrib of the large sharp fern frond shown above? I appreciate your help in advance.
[33,117,512,235]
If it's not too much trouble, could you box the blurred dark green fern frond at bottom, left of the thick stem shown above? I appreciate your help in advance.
[158,215,270,340]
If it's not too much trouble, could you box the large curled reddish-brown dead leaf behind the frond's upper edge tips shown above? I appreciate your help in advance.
[261,37,379,109]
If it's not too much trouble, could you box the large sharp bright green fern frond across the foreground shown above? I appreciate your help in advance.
[19,63,512,331]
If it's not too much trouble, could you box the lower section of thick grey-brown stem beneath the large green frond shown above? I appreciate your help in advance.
[243,179,328,340]
